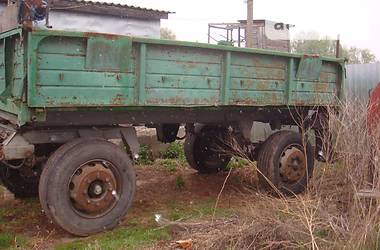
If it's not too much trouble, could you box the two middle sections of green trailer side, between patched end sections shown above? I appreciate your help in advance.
[140,45,287,106]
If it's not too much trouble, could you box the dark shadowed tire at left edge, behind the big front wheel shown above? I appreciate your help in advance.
[0,163,39,198]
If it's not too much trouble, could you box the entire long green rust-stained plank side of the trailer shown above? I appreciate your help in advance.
[28,31,342,108]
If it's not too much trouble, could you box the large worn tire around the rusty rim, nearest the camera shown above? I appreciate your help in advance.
[39,138,136,236]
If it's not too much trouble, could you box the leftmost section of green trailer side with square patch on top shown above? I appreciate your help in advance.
[28,33,136,107]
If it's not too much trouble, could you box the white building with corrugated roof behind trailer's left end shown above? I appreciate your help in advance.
[0,0,169,38]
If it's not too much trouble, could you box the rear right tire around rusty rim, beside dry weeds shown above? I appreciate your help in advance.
[257,131,314,196]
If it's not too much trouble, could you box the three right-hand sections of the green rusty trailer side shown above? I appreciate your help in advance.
[137,44,341,107]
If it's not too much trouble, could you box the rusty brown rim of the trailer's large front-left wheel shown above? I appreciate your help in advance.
[69,160,120,218]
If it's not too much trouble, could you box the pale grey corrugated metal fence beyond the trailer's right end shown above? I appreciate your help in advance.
[346,62,380,102]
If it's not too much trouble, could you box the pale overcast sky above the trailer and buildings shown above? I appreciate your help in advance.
[103,0,380,60]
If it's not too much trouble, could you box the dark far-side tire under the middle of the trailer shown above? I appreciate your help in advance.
[184,125,231,174]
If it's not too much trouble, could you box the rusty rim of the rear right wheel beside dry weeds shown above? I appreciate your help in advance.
[280,145,307,184]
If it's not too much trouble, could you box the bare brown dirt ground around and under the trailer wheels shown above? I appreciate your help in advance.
[0,163,257,249]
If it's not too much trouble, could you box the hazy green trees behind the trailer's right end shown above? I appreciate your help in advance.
[291,32,376,64]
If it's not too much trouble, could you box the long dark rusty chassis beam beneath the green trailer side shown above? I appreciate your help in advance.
[39,106,314,126]
